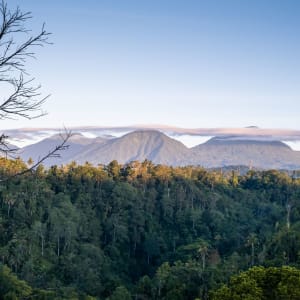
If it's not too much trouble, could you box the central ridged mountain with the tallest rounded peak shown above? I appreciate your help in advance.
[72,130,189,165]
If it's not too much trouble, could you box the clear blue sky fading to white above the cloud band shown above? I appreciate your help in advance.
[1,0,300,129]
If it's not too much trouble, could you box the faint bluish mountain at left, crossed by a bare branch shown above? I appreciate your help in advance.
[19,134,105,166]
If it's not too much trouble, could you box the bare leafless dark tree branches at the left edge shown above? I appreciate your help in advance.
[0,0,71,166]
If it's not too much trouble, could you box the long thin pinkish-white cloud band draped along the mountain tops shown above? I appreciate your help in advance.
[4,125,300,150]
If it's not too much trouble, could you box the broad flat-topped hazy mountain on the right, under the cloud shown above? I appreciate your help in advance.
[189,137,300,169]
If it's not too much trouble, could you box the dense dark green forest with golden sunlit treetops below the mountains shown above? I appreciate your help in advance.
[0,158,300,300]
